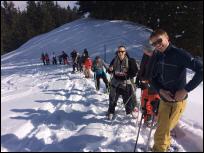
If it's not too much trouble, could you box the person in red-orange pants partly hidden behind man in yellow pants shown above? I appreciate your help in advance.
[136,42,160,127]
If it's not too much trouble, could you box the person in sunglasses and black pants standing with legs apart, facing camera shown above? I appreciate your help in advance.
[108,46,138,120]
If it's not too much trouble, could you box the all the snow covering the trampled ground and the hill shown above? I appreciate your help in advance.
[1,18,203,152]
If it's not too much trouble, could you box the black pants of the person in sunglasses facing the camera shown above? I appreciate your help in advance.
[108,84,136,114]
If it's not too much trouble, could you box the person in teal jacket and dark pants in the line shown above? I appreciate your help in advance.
[92,56,109,92]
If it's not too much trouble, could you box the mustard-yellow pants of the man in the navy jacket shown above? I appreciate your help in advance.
[153,100,186,152]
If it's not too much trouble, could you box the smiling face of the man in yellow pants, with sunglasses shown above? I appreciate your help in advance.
[150,35,169,52]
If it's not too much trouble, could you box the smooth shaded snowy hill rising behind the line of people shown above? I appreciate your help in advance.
[2,19,150,63]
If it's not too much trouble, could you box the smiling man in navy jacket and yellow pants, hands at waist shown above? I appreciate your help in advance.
[150,29,203,152]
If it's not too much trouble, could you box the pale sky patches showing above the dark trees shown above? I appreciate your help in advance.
[3,1,77,10]
